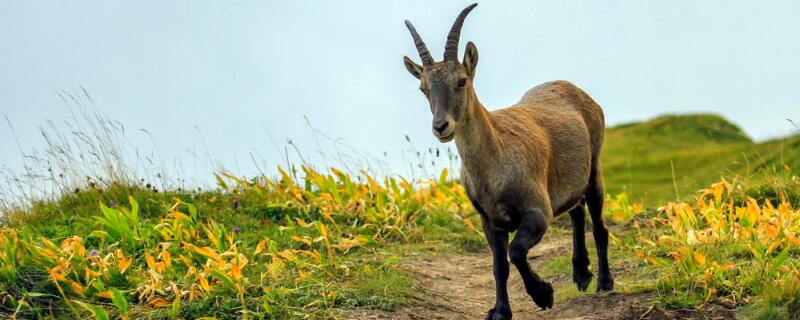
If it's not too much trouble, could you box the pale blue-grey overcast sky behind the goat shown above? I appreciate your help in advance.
[0,0,800,181]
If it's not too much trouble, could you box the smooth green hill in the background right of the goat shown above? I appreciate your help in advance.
[602,114,800,205]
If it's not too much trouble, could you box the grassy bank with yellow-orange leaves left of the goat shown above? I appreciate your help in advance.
[0,168,484,319]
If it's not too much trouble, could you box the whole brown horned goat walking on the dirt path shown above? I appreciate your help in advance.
[404,4,614,319]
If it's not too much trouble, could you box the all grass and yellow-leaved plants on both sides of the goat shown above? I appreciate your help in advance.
[0,115,800,319]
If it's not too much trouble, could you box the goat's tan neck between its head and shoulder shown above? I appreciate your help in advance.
[455,90,501,178]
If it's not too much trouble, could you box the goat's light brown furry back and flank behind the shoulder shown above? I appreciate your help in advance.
[492,81,605,215]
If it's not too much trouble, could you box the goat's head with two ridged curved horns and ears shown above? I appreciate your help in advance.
[403,3,478,142]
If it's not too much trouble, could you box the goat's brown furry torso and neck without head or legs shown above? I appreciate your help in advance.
[455,81,604,231]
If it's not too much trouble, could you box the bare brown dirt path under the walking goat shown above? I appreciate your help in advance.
[348,236,727,320]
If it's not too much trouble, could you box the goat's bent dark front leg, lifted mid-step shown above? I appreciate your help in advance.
[509,209,553,309]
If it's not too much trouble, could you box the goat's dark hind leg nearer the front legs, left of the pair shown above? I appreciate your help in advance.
[569,203,592,291]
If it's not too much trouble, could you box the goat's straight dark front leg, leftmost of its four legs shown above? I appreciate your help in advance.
[481,215,511,320]
